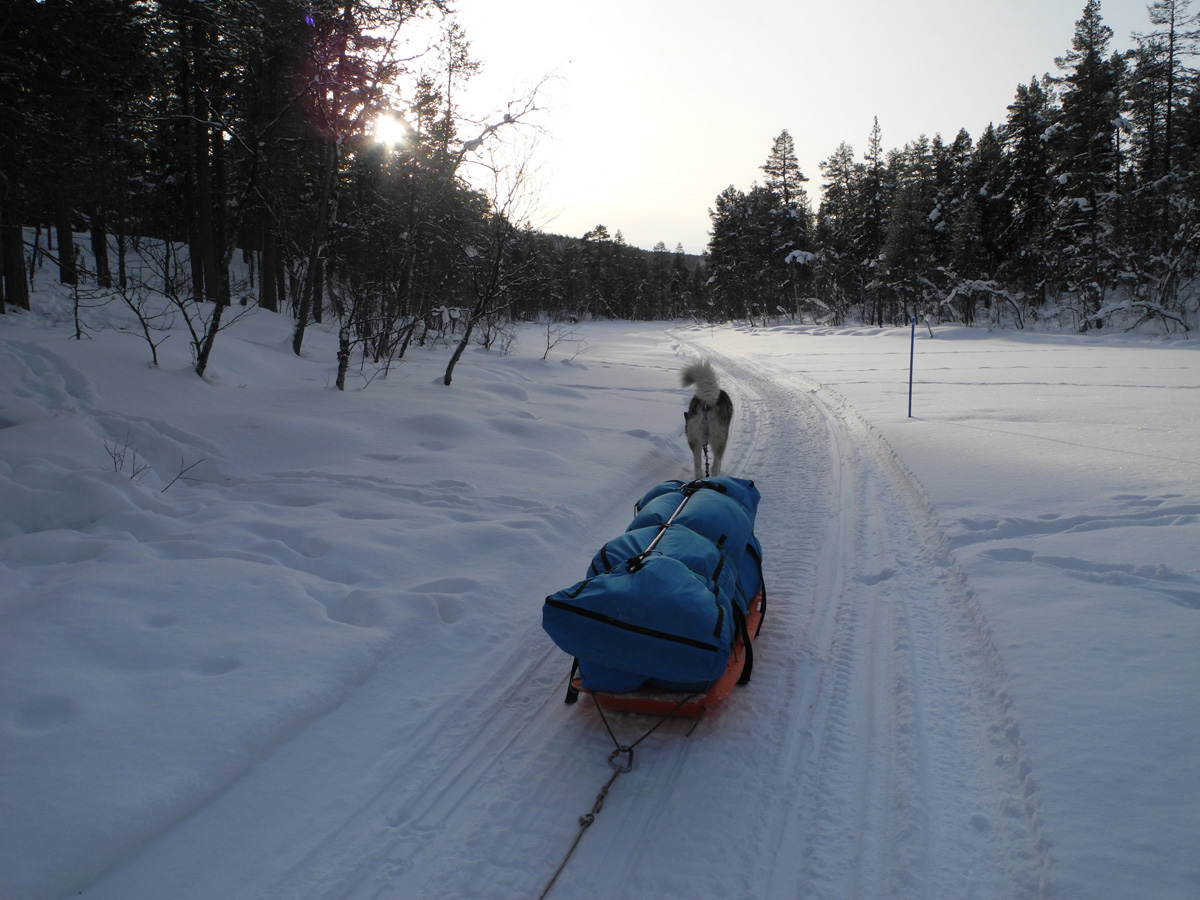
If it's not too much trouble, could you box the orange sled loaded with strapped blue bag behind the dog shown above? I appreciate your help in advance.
[542,478,766,718]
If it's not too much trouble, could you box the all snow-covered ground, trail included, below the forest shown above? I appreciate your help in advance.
[0,292,1200,900]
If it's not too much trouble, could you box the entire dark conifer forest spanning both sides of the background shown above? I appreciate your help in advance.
[0,0,1200,383]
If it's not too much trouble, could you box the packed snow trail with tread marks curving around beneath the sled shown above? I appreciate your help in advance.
[82,336,1054,900]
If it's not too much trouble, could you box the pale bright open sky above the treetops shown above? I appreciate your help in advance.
[454,0,1152,253]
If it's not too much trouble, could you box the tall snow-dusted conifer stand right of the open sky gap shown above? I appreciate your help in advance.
[708,0,1200,336]
